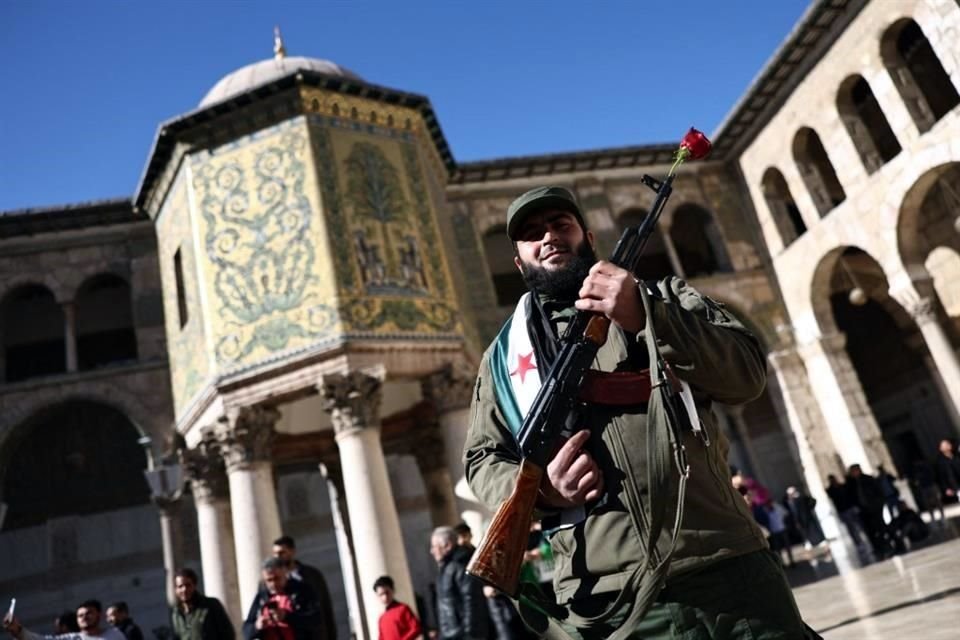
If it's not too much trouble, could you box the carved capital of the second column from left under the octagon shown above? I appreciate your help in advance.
[213,405,280,473]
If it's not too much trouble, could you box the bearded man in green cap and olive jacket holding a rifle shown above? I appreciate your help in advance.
[464,186,817,640]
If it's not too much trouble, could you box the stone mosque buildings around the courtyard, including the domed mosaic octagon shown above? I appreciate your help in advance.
[0,0,960,637]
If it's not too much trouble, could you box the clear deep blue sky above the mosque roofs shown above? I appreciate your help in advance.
[0,0,808,211]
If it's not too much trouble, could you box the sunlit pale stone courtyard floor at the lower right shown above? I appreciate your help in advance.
[788,505,960,640]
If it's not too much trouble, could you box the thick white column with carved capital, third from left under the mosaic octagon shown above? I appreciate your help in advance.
[320,367,415,630]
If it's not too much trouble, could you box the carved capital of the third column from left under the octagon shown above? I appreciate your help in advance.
[318,367,386,438]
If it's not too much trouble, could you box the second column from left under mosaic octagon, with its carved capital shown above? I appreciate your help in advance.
[214,406,280,607]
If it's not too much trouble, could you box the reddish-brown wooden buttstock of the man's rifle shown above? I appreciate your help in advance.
[467,460,543,598]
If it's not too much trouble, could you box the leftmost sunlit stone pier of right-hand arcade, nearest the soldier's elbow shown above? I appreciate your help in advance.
[769,348,859,573]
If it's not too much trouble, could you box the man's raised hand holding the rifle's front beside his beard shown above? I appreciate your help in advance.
[574,261,646,333]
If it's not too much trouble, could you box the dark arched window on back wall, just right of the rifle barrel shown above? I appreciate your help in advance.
[670,204,730,278]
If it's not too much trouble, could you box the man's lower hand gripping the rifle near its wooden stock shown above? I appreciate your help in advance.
[540,430,603,509]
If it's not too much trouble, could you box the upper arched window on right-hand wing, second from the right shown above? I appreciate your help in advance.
[837,75,900,173]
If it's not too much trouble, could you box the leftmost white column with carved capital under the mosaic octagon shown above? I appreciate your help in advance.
[183,431,240,633]
